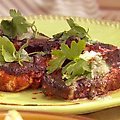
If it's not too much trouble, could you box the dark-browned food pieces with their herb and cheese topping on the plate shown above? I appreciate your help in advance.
[0,10,120,100]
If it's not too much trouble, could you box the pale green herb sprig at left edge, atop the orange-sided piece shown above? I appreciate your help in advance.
[0,37,30,65]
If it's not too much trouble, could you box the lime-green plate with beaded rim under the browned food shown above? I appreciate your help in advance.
[0,16,120,114]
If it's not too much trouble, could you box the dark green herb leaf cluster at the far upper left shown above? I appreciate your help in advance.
[1,9,34,38]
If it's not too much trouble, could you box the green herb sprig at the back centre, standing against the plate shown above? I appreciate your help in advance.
[53,18,89,41]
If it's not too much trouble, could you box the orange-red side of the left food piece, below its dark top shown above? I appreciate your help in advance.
[0,70,33,92]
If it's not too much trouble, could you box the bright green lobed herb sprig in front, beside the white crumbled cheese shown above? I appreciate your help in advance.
[47,40,91,85]
